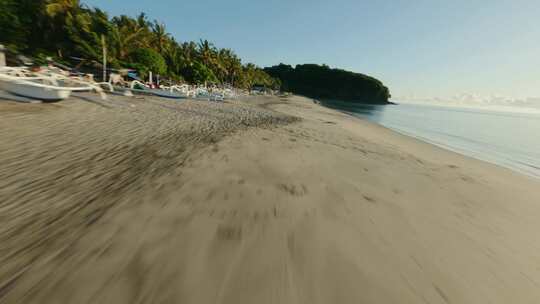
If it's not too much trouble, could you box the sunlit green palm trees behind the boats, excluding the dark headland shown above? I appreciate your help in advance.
[0,0,280,88]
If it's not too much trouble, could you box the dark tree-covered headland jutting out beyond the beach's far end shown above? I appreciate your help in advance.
[264,64,390,104]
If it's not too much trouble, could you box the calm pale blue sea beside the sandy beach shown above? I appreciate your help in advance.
[323,102,540,178]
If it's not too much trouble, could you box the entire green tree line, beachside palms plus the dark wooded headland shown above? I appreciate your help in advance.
[0,0,390,103]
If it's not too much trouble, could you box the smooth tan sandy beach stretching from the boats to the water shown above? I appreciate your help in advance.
[0,97,540,304]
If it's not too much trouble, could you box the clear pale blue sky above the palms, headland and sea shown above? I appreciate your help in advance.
[82,0,540,98]
